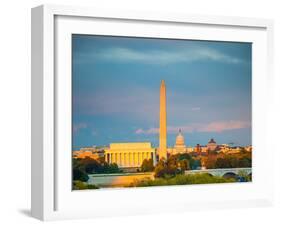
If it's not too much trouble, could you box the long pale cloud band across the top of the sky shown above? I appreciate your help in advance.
[75,46,243,64]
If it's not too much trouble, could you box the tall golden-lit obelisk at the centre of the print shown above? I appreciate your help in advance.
[159,80,167,159]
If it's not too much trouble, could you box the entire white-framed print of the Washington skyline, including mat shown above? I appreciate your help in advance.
[32,5,273,220]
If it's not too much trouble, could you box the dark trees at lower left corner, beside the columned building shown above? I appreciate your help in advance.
[72,157,121,182]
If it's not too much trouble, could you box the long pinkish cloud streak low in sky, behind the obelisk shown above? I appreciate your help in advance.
[135,120,251,135]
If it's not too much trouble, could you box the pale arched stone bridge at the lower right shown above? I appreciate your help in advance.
[185,168,252,177]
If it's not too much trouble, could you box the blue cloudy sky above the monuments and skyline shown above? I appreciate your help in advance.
[72,34,252,149]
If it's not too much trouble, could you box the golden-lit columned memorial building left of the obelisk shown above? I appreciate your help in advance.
[104,142,156,167]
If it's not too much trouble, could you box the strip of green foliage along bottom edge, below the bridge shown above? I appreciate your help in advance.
[131,174,235,187]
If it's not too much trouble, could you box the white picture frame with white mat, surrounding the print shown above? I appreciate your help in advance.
[31,5,274,220]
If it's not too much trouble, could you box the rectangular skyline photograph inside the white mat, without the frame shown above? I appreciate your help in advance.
[71,34,252,190]
